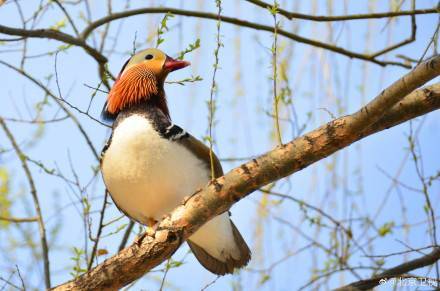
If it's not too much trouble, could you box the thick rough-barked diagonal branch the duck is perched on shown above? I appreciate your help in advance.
[54,57,440,290]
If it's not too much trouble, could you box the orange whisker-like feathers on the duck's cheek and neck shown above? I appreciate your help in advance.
[107,63,159,114]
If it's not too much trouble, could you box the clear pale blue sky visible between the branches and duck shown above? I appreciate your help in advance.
[0,0,440,290]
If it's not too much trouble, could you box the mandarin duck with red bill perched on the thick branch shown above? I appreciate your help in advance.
[100,48,251,275]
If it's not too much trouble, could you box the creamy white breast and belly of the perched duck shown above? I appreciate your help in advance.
[102,115,209,224]
